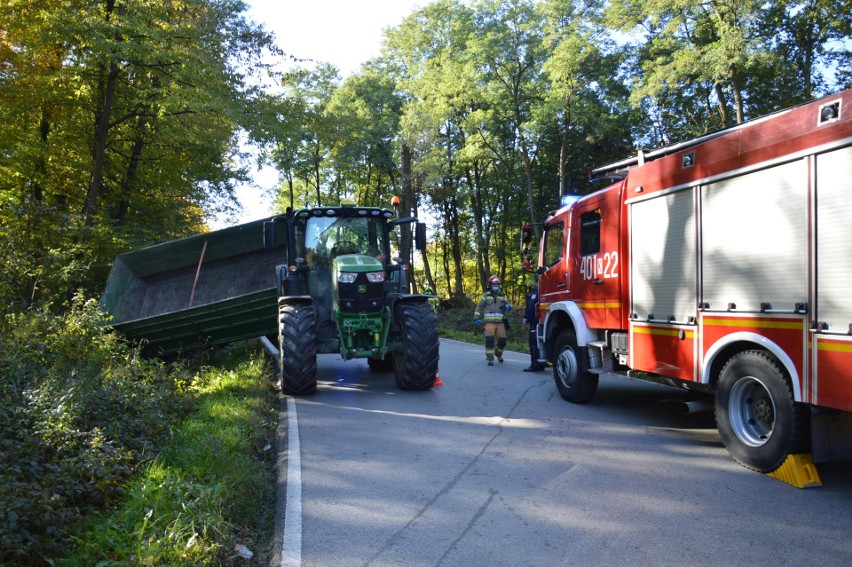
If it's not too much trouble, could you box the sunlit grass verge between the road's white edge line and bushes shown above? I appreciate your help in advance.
[51,341,278,566]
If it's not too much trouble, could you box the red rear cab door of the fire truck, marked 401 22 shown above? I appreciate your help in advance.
[571,199,621,329]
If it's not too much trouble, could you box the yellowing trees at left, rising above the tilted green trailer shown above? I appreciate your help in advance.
[0,0,272,309]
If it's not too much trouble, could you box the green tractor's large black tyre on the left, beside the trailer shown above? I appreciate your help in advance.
[278,305,317,395]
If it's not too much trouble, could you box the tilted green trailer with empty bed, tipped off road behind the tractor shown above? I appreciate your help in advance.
[100,219,287,355]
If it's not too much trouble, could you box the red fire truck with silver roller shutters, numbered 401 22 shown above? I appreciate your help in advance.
[521,90,852,472]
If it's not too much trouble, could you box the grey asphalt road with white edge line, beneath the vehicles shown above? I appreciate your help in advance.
[273,340,852,567]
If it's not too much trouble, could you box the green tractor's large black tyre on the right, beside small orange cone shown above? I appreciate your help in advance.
[393,303,438,390]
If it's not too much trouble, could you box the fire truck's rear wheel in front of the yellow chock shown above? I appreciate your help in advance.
[716,350,810,473]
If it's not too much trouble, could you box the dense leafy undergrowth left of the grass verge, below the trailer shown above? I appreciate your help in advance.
[0,296,188,565]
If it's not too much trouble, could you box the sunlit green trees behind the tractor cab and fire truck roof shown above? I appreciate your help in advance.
[251,0,852,308]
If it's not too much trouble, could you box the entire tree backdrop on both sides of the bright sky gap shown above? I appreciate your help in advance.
[0,0,852,310]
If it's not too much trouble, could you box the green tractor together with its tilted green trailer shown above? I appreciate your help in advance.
[101,203,438,394]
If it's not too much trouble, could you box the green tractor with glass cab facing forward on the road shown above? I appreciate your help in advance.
[264,204,438,394]
